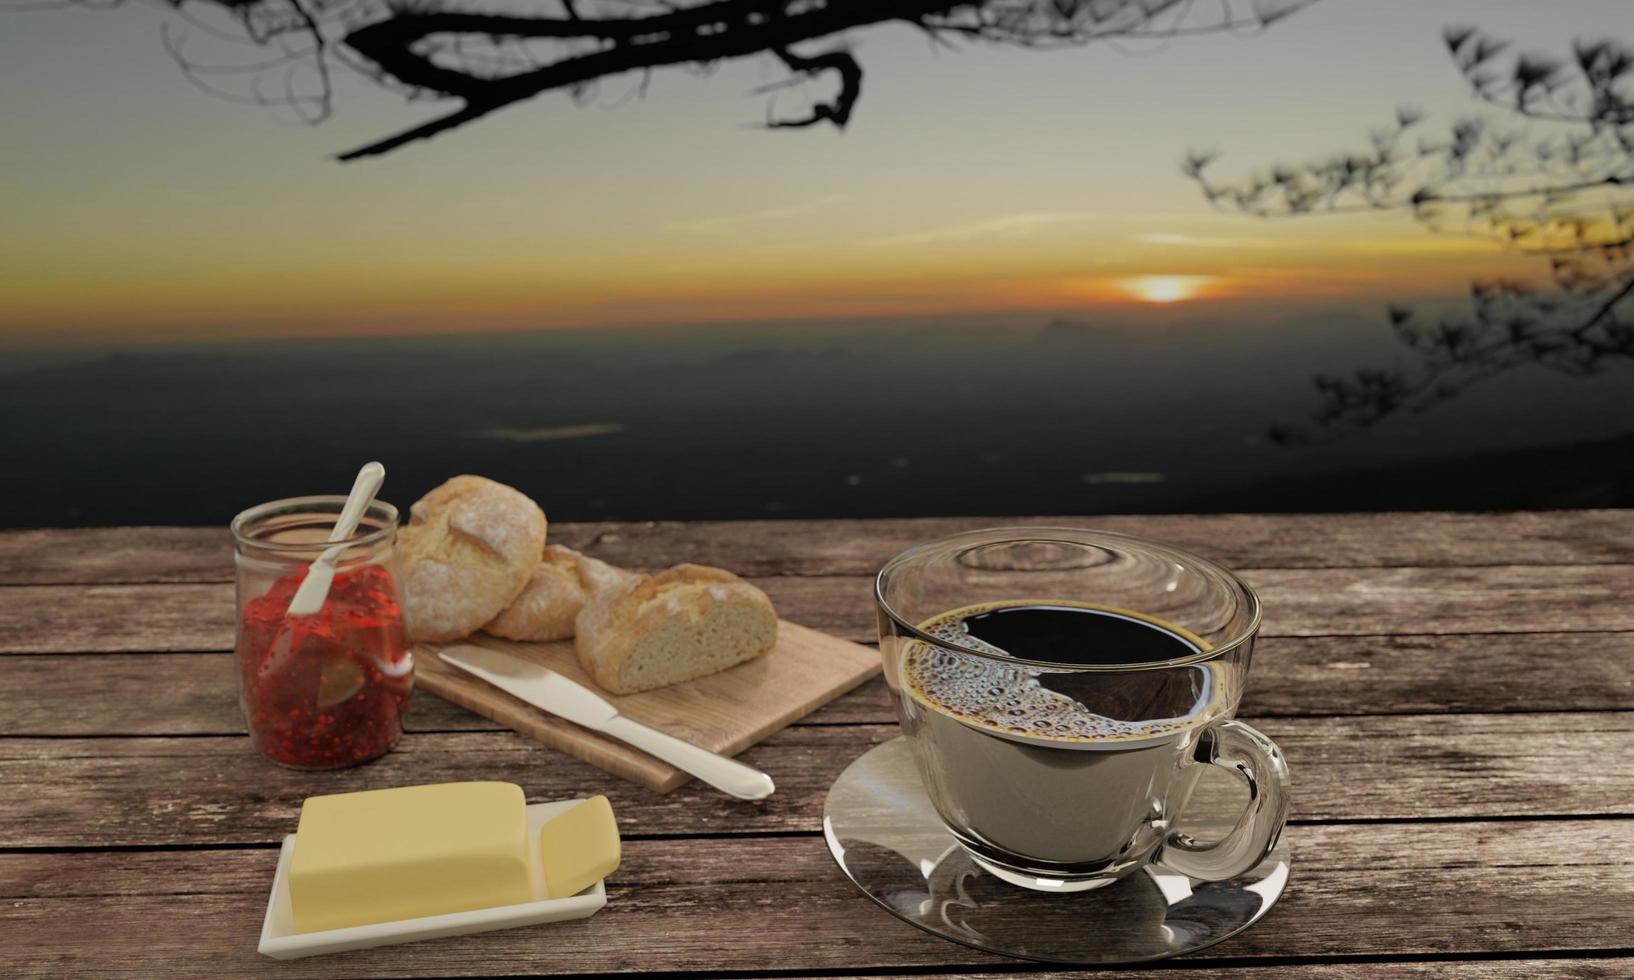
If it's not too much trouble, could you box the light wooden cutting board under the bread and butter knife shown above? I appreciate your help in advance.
[415,622,879,792]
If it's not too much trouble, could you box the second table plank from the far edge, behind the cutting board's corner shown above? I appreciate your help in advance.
[0,565,1634,653]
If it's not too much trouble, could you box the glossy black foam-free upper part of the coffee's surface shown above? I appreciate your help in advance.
[962,604,1198,666]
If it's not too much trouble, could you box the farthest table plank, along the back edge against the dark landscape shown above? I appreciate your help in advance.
[12,510,1634,585]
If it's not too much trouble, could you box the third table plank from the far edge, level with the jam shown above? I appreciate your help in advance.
[12,632,1634,737]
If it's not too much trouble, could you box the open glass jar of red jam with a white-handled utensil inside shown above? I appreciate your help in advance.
[232,497,413,769]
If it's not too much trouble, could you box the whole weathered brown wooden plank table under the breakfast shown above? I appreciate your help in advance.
[0,511,1634,980]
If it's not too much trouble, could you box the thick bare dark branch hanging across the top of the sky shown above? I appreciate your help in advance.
[20,0,1315,160]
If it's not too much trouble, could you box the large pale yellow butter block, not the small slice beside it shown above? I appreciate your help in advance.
[289,782,529,933]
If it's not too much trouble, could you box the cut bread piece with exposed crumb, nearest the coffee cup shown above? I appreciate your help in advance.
[574,565,778,694]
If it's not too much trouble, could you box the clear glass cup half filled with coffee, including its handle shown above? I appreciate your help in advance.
[876,528,1288,892]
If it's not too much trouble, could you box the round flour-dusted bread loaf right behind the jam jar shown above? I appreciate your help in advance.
[397,477,546,640]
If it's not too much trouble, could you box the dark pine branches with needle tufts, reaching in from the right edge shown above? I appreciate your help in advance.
[1181,28,1634,444]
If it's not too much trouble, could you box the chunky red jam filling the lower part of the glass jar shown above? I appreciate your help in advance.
[239,565,413,769]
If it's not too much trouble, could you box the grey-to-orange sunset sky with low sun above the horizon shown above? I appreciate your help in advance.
[0,0,1626,346]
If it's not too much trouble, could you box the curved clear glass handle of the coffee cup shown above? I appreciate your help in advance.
[1155,719,1288,882]
